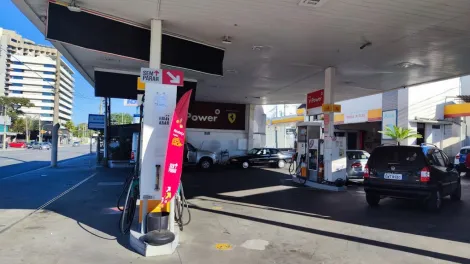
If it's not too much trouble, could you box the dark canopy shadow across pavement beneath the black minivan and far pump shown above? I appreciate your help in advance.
[182,166,470,263]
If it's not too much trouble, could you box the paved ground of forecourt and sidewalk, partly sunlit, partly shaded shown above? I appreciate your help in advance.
[0,162,470,264]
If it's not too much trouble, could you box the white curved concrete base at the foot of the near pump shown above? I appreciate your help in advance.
[129,226,180,257]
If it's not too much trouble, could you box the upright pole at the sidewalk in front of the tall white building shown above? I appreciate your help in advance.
[51,52,60,167]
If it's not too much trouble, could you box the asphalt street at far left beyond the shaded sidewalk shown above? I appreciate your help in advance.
[0,145,90,179]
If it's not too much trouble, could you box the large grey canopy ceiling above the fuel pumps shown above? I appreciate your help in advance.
[12,0,470,104]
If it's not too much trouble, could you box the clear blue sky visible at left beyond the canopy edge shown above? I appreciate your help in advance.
[0,0,135,124]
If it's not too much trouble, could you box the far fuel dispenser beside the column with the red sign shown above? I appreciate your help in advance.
[296,121,346,189]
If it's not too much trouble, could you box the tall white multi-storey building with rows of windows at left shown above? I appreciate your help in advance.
[0,28,75,124]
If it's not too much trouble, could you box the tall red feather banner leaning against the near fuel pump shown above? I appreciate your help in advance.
[160,90,192,207]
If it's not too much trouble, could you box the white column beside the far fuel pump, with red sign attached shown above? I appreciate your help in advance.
[324,67,336,180]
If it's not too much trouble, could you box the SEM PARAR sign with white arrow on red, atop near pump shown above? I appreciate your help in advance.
[140,68,184,86]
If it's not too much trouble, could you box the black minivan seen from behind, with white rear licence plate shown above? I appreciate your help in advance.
[364,145,461,211]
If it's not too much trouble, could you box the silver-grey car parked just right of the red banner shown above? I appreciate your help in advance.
[183,142,219,170]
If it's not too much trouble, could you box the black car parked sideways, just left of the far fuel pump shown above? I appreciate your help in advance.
[229,148,292,169]
